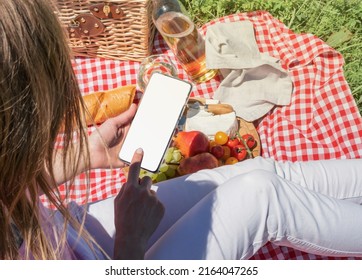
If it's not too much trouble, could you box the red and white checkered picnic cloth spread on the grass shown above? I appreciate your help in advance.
[49,11,362,259]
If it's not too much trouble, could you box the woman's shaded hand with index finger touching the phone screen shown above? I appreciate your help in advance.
[114,149,165,259]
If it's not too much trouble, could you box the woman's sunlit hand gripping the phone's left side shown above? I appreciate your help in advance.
[89,104,137,168]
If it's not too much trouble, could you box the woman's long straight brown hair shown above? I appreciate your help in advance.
[0,0,89,259]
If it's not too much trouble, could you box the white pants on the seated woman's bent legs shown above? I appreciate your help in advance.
[89,157,362,259]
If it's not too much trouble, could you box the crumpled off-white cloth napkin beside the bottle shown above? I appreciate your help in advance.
[205,21,293,121]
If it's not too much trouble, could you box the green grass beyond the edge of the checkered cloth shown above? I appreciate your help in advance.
[180,0,362,113]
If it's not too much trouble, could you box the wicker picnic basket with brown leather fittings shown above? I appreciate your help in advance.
[55,0,155,61]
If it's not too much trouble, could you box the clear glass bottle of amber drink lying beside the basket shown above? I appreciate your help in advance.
[152,0,218,83]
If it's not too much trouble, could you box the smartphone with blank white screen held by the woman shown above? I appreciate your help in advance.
[119,73,192,172]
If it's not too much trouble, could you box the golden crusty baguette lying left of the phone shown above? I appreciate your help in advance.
[83,85,136,126]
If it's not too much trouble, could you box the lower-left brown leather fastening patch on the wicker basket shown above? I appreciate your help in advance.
[67,14,105,38]
